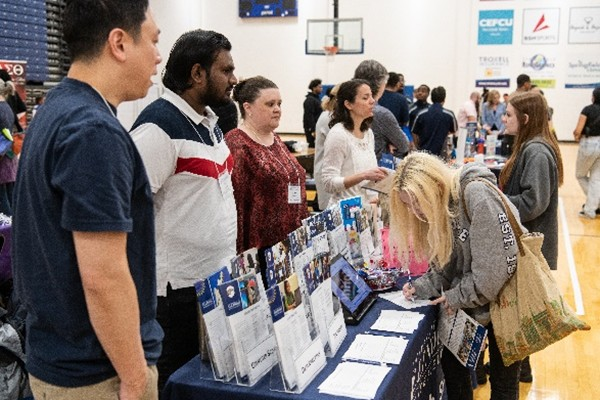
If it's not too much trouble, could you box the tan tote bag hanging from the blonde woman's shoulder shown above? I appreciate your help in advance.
[466,179,590,366]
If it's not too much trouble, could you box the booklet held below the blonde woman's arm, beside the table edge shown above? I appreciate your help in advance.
[438,308,487,369]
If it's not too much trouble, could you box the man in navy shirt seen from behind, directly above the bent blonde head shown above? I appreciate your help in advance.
[413,86,458,157]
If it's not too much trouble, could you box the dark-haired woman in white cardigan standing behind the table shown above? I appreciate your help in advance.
[322,79,387,205]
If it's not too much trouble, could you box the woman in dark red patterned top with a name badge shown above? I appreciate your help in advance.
[225,76,308,253]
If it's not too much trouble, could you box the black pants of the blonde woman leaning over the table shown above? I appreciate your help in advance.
[442,324,521,400]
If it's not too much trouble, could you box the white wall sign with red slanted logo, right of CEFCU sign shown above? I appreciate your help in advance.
[523,8,560,44]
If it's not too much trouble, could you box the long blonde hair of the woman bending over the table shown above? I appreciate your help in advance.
[390,152,460,267]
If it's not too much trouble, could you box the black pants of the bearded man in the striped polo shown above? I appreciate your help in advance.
[156,284,199,393]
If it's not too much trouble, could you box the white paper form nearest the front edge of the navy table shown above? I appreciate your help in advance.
[319,362,391,399]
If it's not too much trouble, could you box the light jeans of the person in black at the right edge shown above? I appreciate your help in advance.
[575,136,600,218]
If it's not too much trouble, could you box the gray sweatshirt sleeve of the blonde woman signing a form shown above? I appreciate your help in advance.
[445,181,519,309]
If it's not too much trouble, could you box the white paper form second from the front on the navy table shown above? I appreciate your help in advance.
[342,334,408,365]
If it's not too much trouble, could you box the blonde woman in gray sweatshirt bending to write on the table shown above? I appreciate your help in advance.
[390,152,527,400]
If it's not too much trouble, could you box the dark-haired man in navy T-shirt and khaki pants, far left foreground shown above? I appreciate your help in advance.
[12,0,163,399]
